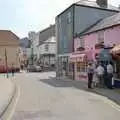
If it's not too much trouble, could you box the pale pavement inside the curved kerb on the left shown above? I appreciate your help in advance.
[0,74,15,120]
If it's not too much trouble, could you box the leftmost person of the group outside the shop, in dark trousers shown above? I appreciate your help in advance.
[87,63,94,88]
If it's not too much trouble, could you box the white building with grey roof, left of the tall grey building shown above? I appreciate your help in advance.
[29,25,56,66]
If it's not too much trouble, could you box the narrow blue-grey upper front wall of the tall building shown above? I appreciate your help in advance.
[56,6,73,54]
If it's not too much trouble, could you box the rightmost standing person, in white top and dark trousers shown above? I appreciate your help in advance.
[107,62,113,89]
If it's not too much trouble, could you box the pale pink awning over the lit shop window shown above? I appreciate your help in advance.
[69,53,87,62]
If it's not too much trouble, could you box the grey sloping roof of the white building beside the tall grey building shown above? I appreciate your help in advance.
[39,25,55,45]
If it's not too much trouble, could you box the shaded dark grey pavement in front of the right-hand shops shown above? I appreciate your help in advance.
[54,77,120,105]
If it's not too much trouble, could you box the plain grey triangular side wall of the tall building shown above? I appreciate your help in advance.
[74,6,116,34]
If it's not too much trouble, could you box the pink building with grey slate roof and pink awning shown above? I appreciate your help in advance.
[70,13,120,80]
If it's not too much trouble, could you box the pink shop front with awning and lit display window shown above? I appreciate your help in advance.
[69,51,93,81]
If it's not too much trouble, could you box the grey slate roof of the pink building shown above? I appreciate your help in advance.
[83,13,120,34]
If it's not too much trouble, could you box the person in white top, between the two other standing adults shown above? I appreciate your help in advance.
[96,63,104,87]
